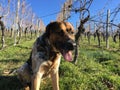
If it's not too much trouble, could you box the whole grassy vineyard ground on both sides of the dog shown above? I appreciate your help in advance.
[0,35,120,90]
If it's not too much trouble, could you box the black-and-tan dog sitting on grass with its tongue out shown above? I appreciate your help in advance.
[17,21,76,90]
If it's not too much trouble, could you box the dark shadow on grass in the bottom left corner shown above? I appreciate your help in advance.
[0,76,23,90]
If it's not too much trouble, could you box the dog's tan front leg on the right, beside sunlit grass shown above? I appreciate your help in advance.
[51,70,59,90]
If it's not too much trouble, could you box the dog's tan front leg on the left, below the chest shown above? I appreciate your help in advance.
[31,72,43,90]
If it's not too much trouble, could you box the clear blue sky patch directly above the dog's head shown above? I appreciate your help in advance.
[27,0,65,24]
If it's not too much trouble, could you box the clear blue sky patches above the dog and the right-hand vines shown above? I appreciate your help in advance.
[27,0,120,25]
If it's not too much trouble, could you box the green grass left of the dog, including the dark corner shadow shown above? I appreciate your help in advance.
[0,37,34,90]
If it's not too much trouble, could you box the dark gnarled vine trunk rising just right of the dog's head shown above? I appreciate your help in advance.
[73,0,93,64]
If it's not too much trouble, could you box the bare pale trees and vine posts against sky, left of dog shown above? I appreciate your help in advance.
[0,0,45,48]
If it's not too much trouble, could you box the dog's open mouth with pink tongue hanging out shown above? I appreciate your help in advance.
[61,50,73,62]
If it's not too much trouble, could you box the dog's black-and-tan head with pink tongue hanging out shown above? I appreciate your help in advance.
[46,22,76,61]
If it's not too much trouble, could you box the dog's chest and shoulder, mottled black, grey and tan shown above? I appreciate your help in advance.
[32,37,61,74]
